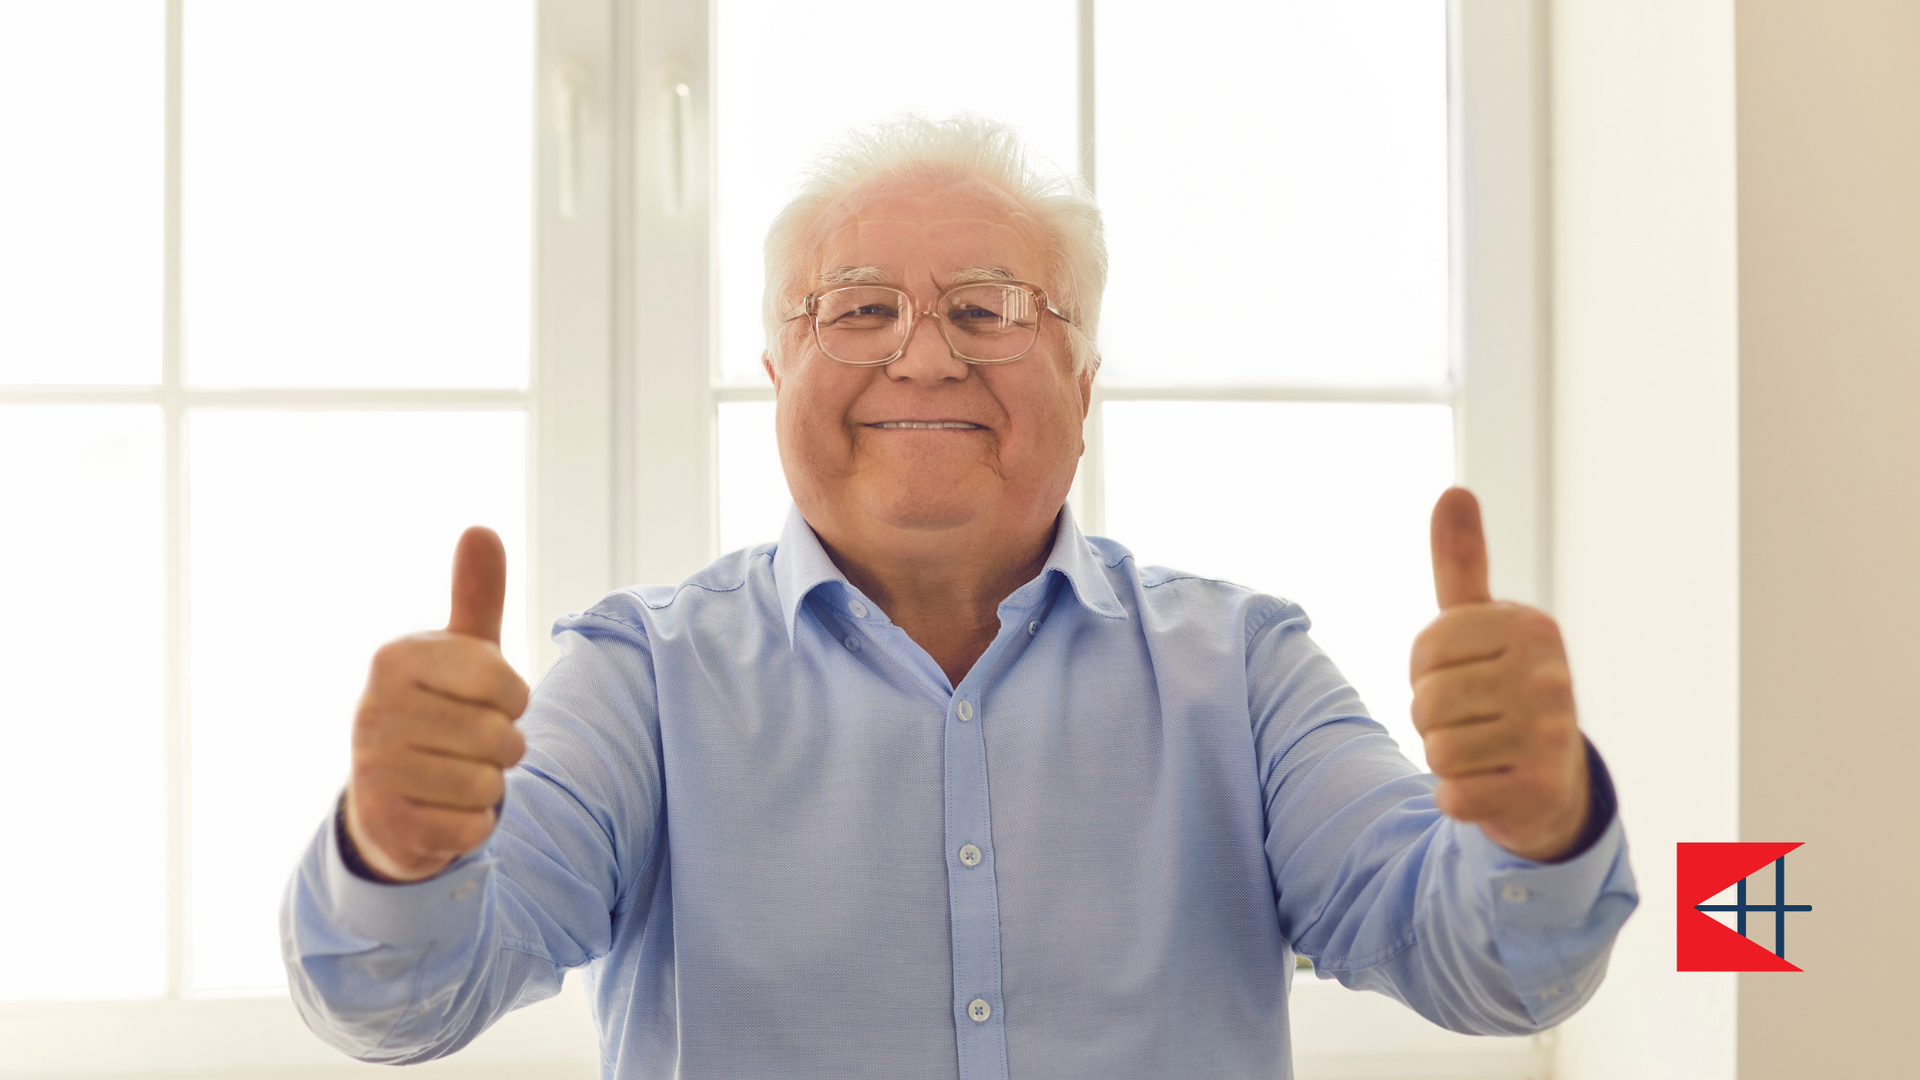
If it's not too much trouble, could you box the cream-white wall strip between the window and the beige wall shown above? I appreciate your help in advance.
[1551,0,1740,1080]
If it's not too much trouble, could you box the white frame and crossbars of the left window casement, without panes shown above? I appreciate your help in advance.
[0,0,610,1080]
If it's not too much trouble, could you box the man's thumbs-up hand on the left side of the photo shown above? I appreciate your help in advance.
[346,527,526,882]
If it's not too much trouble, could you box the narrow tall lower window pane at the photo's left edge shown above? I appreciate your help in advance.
[0,405,167,1001]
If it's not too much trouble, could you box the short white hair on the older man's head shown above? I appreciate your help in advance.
[760,113,1106,373]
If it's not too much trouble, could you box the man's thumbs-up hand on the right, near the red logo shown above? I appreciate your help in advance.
[1413,488,1592,861]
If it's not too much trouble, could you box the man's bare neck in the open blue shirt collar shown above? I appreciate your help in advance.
[820,517,1058,686]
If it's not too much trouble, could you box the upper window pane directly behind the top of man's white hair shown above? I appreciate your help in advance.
[714,0,1079,382]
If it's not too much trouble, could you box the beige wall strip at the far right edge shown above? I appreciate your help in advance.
[1738,0,1920,1080]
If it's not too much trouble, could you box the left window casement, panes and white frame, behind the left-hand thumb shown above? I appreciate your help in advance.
[0,0,611,1074]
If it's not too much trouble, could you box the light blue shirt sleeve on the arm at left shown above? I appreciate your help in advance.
[280,613,664,1065]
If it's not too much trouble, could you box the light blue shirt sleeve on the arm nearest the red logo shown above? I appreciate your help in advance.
[1248,605,1640,1034]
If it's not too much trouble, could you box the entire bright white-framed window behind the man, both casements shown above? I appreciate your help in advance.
[0,0,1546,1076]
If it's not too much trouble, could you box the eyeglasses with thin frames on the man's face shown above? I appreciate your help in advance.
[781,281,1071,367]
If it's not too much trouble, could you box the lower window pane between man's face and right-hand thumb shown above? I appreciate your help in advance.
[1102,402,1453,763]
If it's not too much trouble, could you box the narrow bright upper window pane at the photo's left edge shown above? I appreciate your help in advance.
[0,0,167,382]
